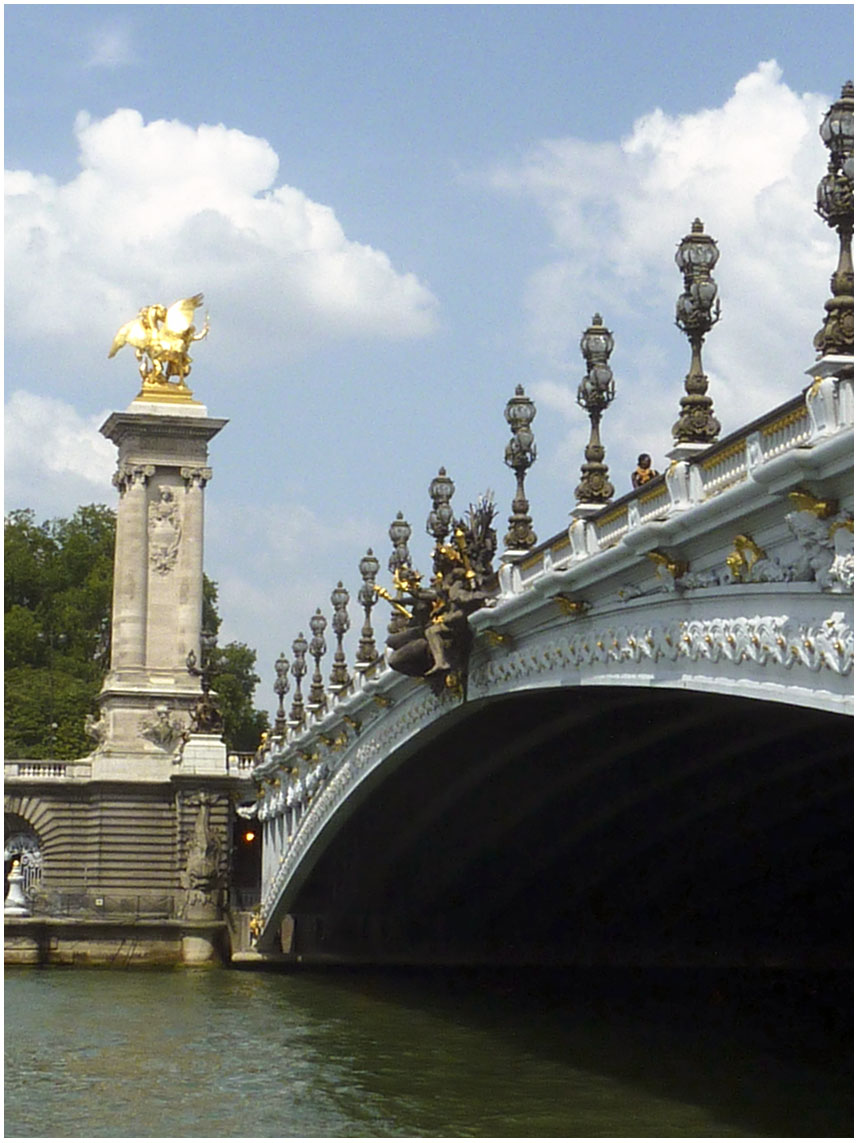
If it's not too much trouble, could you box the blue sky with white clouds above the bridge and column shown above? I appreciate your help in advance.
[5,5,853,711]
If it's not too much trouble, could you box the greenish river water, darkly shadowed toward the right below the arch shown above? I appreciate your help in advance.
[5,968,852,1138]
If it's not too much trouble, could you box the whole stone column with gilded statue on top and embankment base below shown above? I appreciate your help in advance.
[5,295,249,964]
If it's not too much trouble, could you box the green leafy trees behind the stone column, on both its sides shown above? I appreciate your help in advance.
[3,504,268,758]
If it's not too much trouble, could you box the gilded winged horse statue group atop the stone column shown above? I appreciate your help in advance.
[107,294,209,397]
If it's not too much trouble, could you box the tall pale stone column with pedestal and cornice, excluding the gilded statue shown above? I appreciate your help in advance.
[93,399,226,782]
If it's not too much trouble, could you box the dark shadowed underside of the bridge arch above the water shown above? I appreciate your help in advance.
[288,687,853,966]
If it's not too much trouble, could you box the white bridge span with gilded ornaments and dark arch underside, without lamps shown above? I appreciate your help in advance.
[247,358,853,964]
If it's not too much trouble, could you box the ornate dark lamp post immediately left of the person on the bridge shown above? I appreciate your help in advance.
[573,313,615,517]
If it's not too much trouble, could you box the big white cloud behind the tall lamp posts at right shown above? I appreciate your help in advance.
[492,61,837,464]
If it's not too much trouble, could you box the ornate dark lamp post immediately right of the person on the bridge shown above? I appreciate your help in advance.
[669,218,722,450]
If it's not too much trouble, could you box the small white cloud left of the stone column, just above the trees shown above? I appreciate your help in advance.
[3,390,117,515]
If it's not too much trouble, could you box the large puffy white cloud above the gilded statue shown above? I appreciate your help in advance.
[6,110,436,360]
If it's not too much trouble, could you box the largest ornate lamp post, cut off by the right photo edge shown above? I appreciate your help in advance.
[814,82,853,357]
